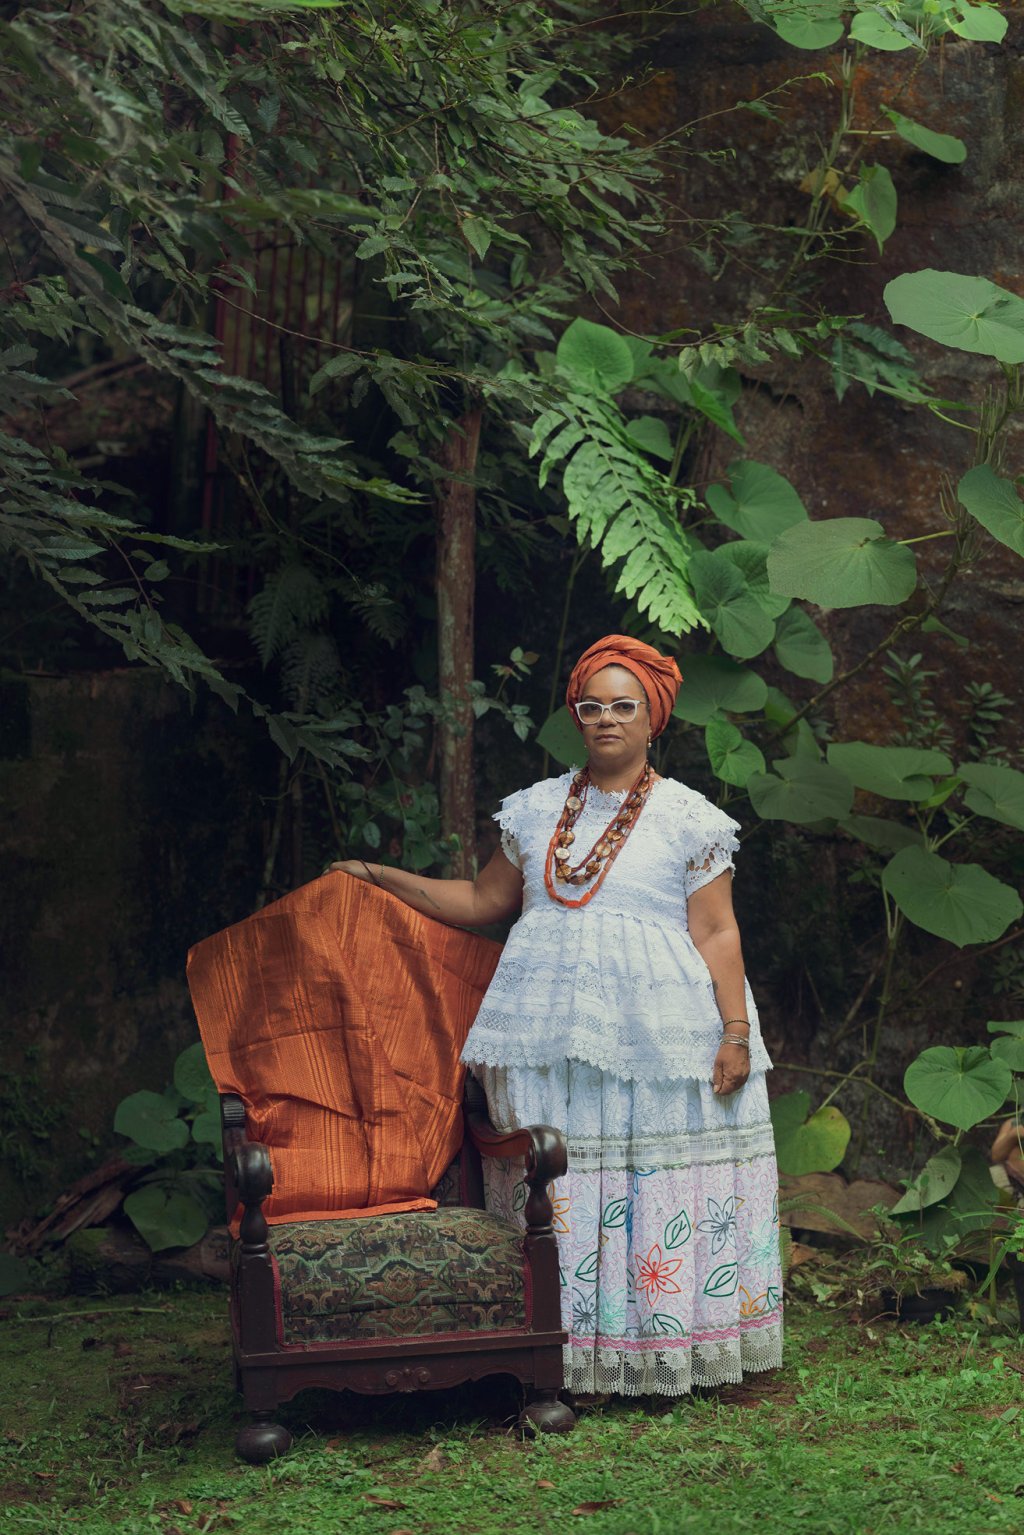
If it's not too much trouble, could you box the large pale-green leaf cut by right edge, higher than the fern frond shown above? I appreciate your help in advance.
[883,267,1024,362]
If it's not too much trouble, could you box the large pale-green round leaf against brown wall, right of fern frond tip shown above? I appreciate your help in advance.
[768,517,917,608]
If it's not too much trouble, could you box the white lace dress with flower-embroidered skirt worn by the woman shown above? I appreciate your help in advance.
[462,774,783,1395]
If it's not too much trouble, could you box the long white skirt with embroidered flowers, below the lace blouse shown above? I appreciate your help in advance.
[477,1059,783,1395]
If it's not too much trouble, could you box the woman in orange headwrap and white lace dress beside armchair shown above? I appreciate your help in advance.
[333,634,781,1395]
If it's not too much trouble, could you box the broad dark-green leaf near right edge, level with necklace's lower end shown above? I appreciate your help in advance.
[881,847,1024,949]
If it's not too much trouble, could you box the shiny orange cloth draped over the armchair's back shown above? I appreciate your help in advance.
[187,873,500,1222]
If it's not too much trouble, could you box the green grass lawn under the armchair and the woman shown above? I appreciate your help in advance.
[0,1292,1024,1535]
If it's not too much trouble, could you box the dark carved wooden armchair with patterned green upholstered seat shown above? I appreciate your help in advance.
[221,1078,576,1464]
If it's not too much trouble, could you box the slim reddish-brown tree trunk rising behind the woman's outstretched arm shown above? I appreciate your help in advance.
[438,407,482,880]
